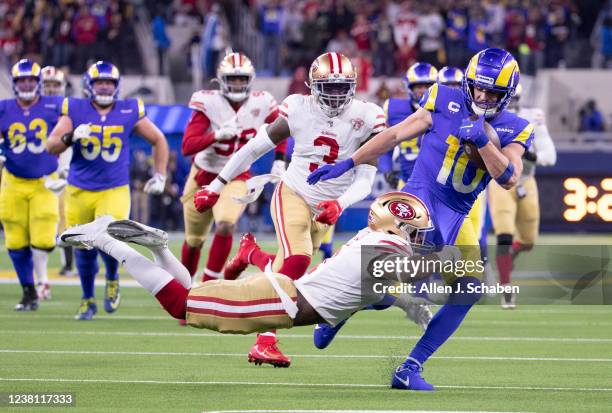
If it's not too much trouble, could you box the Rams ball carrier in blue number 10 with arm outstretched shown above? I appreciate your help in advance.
[308,48,533,390]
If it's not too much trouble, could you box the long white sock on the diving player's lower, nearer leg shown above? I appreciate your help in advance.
[94,233,174,295]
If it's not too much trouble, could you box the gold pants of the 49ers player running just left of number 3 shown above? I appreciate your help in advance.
[181,165,247,247]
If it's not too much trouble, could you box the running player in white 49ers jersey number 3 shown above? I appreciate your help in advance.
[195,53,385,366]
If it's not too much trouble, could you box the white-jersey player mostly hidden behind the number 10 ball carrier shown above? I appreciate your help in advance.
[489,84,557,309]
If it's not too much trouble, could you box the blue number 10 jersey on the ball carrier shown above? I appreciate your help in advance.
[409,84,533,214]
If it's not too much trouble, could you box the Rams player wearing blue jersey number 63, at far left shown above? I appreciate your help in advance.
[0,59,61,311]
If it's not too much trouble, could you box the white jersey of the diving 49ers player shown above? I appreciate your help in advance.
[294,228,413,325]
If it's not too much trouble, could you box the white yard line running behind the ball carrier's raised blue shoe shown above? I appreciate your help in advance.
[0,330,612,343]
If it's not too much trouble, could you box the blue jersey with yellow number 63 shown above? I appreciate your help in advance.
[0,96,62,179]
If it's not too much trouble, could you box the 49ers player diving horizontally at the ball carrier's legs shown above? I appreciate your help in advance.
[61,192,460,382]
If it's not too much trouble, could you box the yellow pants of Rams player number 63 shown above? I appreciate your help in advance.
[0,168,59,250]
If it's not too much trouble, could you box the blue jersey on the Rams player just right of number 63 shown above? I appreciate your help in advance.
[62,98,145,191]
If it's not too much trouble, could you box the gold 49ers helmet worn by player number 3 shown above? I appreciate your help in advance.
[308,52,357,117]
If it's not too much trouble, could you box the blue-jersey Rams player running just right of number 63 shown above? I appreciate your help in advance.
[47,61,168,320]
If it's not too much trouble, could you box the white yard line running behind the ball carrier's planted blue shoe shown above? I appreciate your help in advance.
[0,377,612,392]
